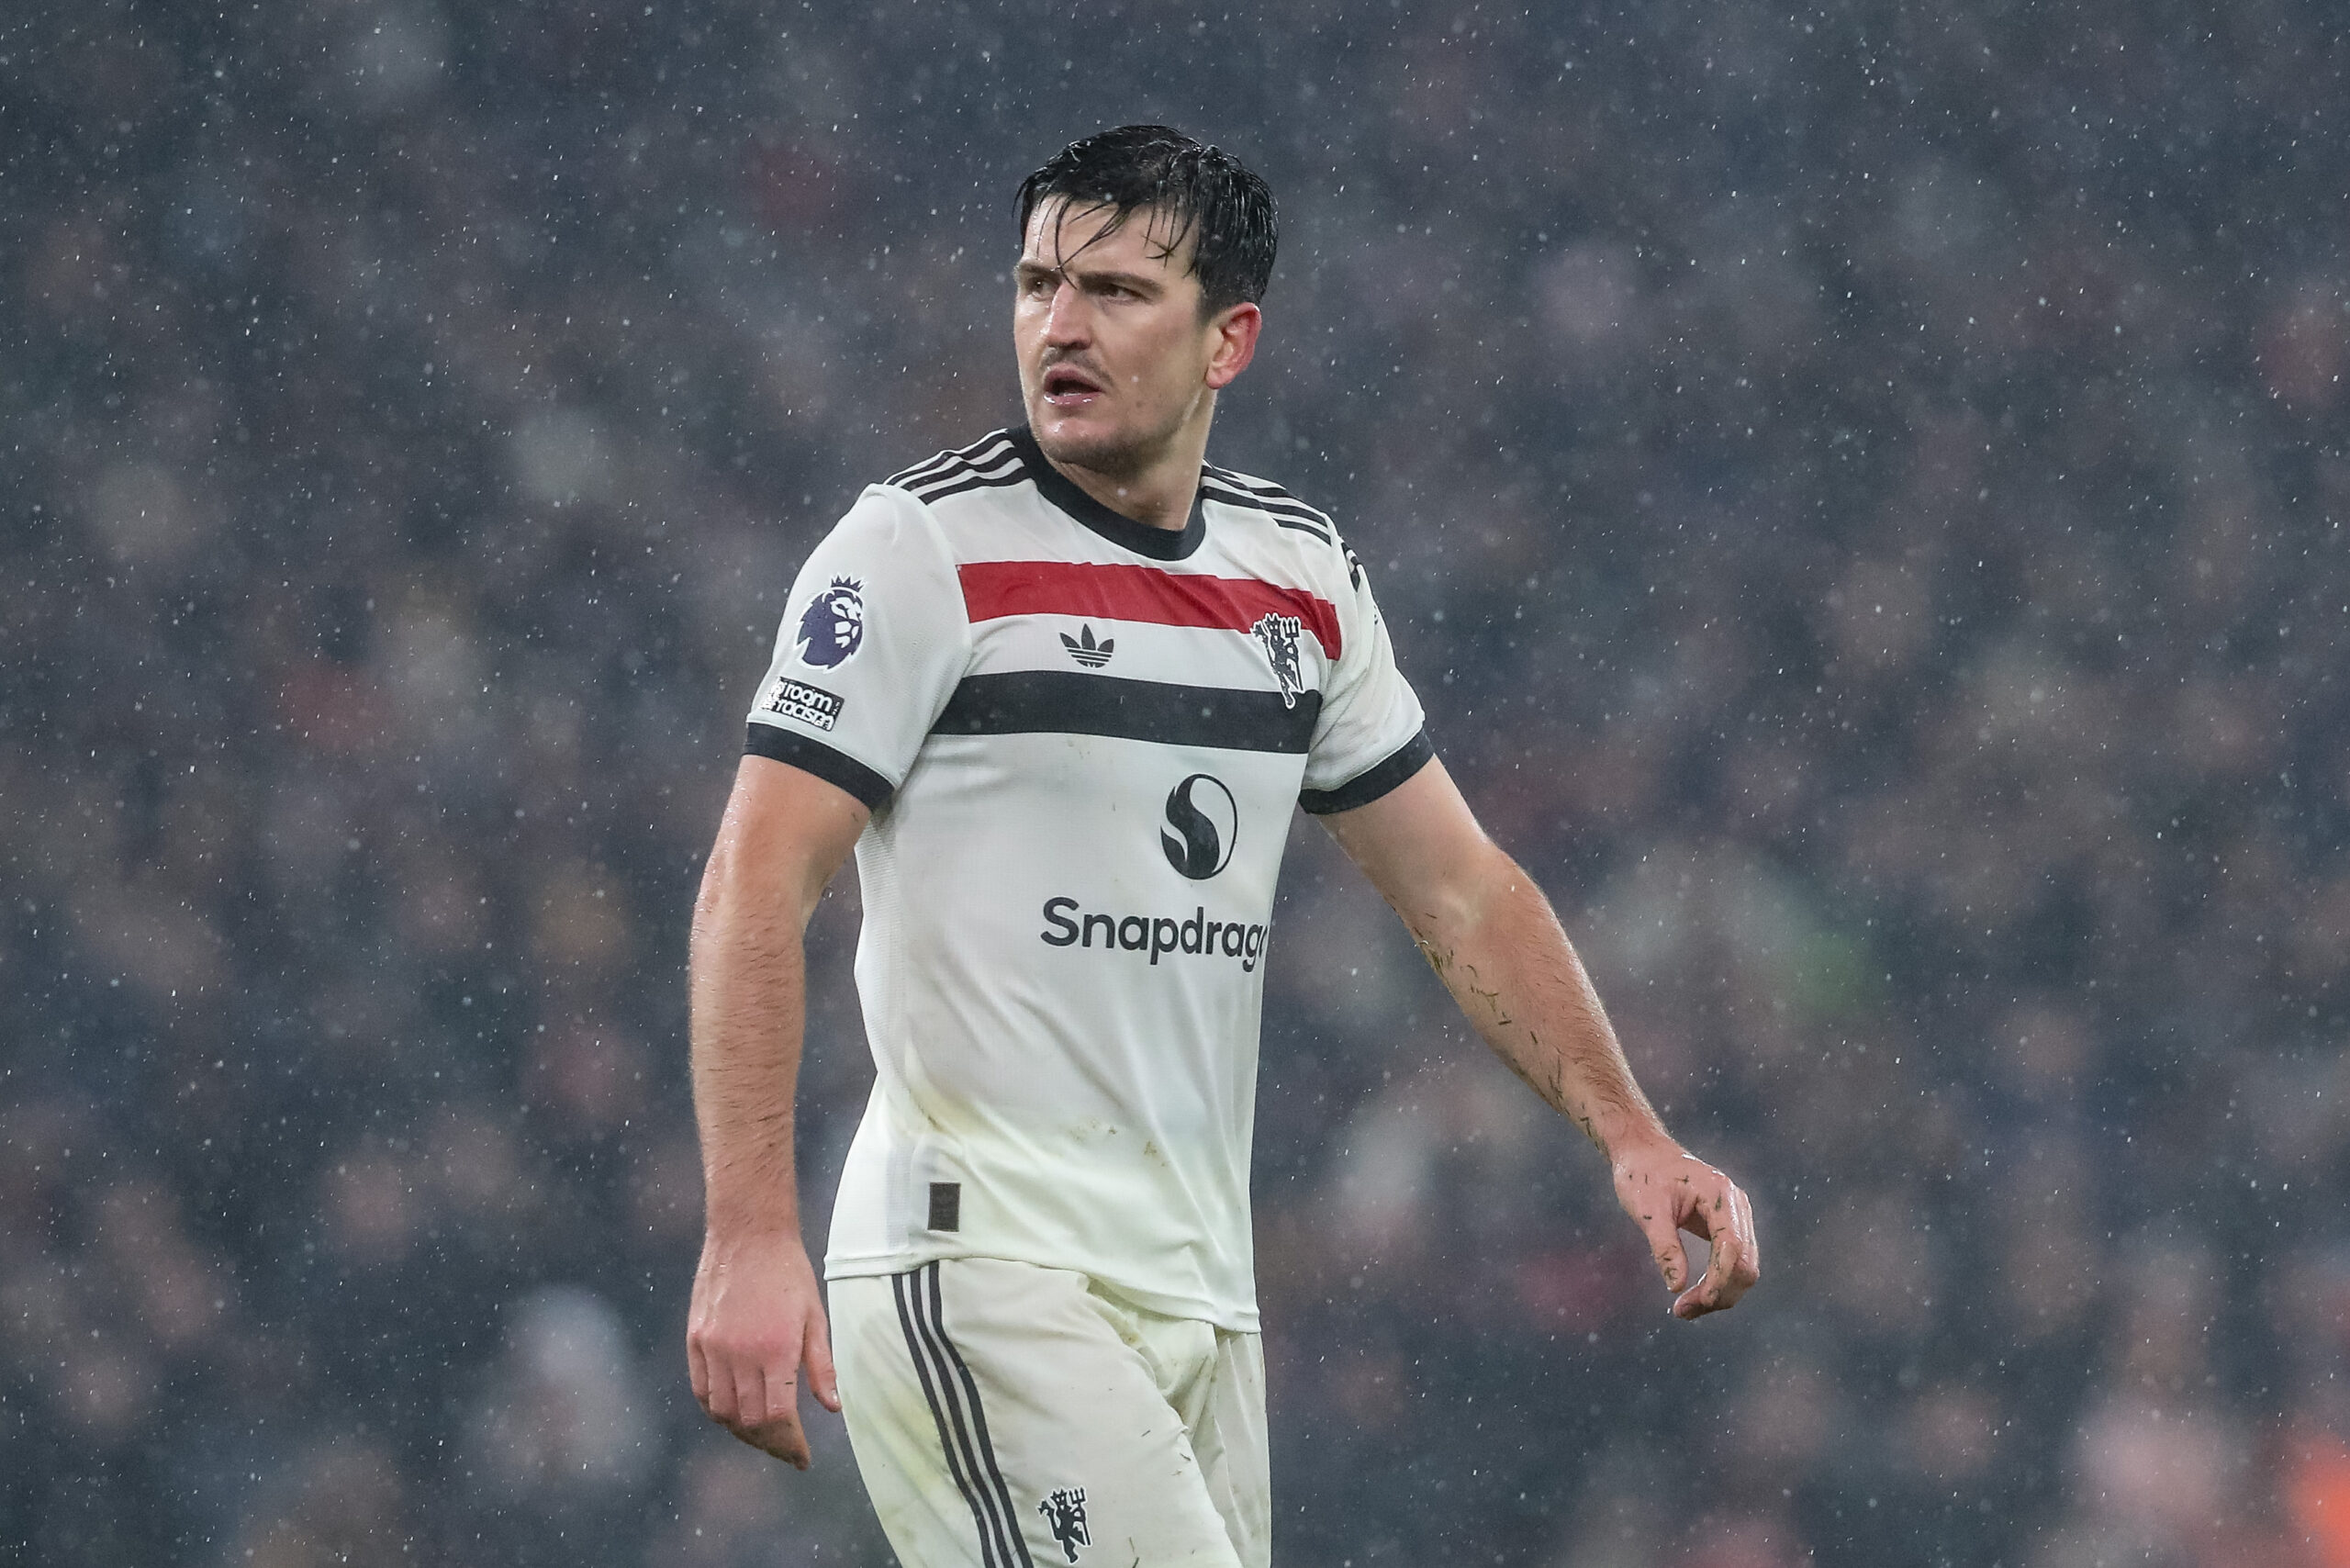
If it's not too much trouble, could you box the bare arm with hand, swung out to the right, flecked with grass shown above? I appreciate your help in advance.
[1323,762,1760,1316]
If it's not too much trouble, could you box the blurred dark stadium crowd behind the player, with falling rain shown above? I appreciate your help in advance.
[0,0,2350,1568]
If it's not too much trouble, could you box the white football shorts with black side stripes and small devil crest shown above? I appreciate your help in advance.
[830,1258,1274,1568]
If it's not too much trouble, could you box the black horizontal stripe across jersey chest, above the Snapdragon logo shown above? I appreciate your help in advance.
[931,670,1321,755]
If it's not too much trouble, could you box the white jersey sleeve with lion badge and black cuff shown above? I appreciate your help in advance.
[745,485,970,809]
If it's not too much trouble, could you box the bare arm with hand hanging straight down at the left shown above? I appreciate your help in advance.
[687,757,867,1469]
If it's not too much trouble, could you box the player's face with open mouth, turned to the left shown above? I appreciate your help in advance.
[1013,197,1258,475]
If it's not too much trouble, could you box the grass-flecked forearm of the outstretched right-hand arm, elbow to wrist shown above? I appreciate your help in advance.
[1403,842,1669,1159]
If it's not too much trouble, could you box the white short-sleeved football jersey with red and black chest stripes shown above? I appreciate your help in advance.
[750,431,1431,1330]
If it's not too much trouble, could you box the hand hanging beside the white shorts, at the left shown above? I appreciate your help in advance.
[687,1234,841,1469]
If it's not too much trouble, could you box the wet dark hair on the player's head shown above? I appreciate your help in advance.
[1020,125,1279,315]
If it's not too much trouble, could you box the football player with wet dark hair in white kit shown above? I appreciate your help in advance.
[687,125,1758,1568]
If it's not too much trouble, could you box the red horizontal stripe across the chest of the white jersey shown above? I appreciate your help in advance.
[958,562,1337,658]
